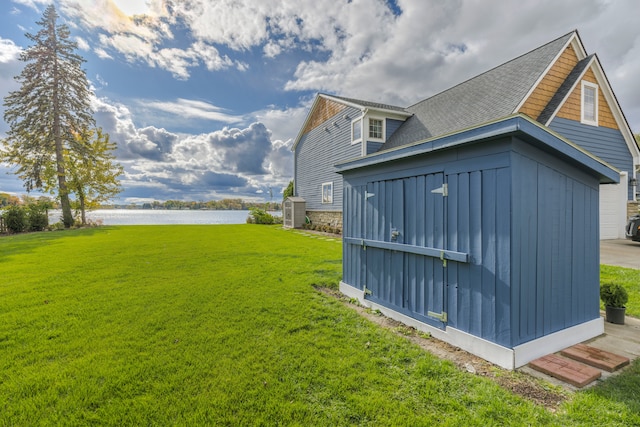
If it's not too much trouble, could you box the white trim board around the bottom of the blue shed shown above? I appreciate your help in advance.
[340,281,604,369]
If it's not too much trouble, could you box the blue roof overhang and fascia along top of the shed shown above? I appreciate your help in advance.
[335,114,620,184]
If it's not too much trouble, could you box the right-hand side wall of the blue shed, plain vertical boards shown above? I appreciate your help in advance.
[511,145,599,346]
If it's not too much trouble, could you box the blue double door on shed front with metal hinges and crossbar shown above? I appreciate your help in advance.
[363,173,447,328]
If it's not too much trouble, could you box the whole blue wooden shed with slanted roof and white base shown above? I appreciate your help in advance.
[336,114,619,369]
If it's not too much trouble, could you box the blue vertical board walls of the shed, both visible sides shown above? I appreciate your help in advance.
[344,133,599,348]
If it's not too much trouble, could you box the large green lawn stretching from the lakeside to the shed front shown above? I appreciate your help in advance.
[0,225,640,426]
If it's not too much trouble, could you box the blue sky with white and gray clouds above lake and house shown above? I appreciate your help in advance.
[0,0,640,203]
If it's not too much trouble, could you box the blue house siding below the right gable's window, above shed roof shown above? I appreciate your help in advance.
[549,117,633,200]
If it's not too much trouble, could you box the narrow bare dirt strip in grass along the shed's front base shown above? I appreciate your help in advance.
[317,287,569,412]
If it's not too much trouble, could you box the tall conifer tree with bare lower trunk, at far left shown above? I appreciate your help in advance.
[0,4,94,227]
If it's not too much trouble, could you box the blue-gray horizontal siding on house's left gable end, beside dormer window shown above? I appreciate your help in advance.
[294,107,362,212]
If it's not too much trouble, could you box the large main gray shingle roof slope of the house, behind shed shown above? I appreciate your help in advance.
[380,32,574,151]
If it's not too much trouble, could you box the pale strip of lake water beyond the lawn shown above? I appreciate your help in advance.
[49,209,280,225]
